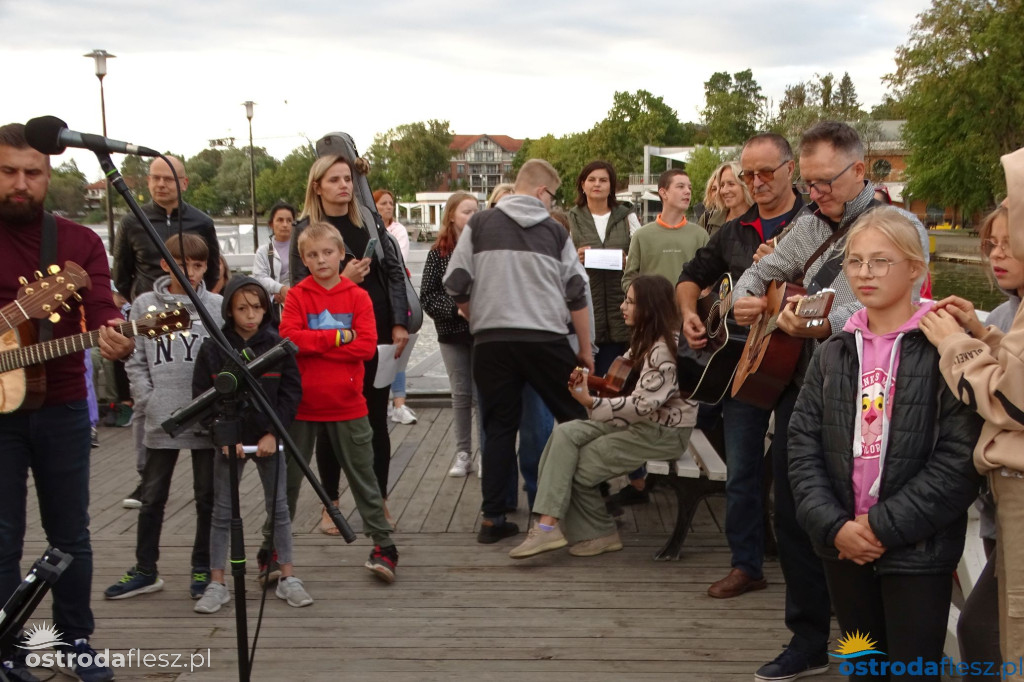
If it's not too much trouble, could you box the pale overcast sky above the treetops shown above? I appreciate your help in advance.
[0,0,929,179]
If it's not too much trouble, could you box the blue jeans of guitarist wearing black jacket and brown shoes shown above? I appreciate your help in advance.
[722,397,771,580]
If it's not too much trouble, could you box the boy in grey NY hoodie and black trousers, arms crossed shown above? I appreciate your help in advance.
[103,232,223,599]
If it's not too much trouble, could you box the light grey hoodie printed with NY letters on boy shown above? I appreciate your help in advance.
[125,275,223,450]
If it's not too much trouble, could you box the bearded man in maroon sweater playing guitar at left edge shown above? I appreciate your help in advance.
[0,123,134,682]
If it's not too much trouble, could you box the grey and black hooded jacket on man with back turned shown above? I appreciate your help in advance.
[444,195,588,343]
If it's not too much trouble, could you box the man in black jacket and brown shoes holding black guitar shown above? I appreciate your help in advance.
[676,133,804,599]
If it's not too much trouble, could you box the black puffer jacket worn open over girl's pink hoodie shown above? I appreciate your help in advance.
[790,330,981,574]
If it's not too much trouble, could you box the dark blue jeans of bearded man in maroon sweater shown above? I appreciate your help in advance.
[0,400,93,641]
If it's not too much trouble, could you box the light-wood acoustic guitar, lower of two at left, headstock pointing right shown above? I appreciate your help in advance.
[0,304,193,415]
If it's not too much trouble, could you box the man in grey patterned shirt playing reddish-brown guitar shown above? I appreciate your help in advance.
[726,121,928,680]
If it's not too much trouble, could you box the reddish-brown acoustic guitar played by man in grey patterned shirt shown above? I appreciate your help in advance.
[732,282,836,410]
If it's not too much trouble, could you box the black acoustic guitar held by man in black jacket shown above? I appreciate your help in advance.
[676,273,746,404]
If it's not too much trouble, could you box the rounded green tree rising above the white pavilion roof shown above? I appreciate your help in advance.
[700,69,767,144]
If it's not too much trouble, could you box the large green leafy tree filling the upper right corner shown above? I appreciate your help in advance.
[884,0,1024,215]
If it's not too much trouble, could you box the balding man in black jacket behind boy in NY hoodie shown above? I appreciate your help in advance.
[113,156,220,301]
